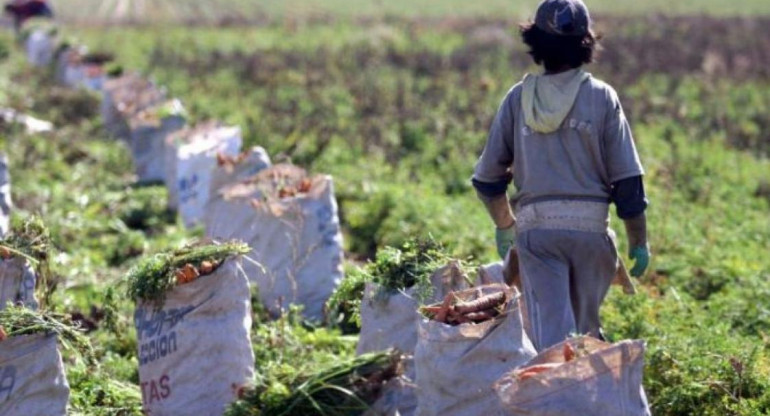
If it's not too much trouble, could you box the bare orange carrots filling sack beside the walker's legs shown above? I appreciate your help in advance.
[420,288,511,325]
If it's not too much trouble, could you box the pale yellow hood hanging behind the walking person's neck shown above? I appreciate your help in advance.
[521,68,591,133]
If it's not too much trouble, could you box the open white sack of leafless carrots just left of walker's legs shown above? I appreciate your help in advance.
[415,284,535,416]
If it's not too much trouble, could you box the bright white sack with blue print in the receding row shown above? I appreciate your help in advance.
[165,124,242,226]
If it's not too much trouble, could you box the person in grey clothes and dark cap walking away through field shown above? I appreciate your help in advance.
[472,0,650,351]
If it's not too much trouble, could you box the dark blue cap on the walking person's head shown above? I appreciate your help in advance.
[535,0,591,36]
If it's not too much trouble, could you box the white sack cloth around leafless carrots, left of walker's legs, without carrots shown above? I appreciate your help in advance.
[414,285,535,416]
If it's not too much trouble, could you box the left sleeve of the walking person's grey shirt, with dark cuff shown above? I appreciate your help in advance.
[472,92,513,197]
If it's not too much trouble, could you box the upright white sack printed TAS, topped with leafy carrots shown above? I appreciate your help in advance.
[128,242,254,415]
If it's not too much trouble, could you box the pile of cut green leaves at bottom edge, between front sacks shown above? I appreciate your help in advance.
[225,351,401,416]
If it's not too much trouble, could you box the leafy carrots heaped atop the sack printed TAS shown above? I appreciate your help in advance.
[127,242,250,304]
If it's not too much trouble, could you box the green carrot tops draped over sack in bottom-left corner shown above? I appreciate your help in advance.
[0,305,94,361]
